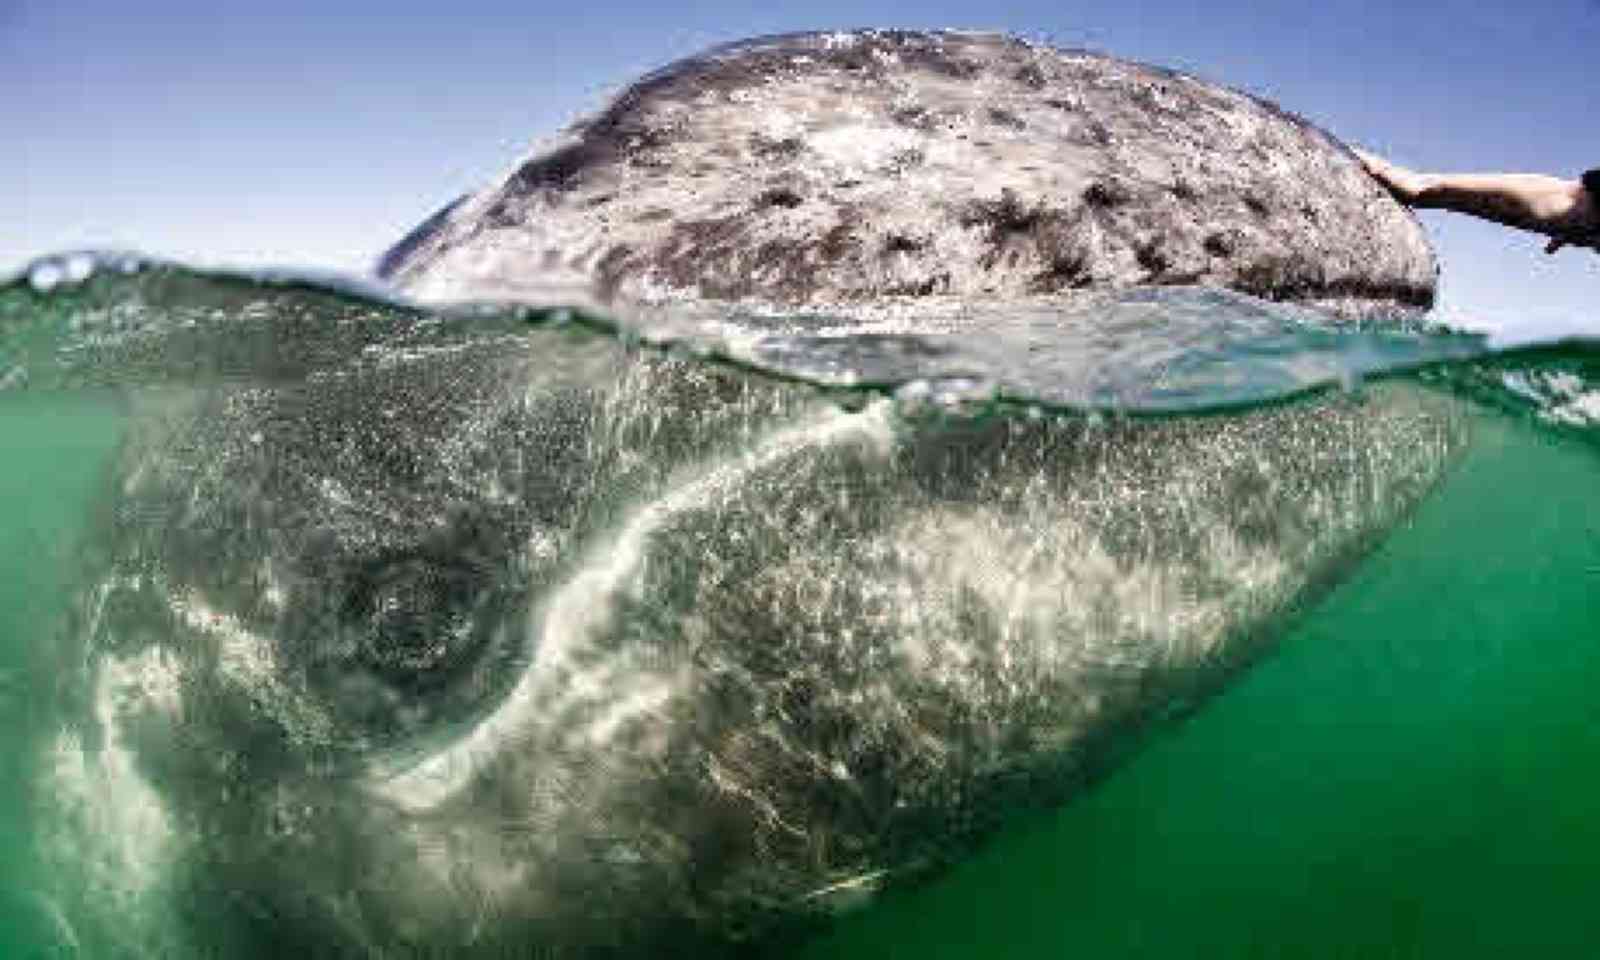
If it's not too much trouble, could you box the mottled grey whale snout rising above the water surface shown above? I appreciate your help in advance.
[378,30,1437,317]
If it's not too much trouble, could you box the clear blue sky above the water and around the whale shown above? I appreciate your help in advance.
[0,0,1600,338]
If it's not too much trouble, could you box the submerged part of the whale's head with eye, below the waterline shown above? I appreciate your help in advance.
[35,270,1462,957]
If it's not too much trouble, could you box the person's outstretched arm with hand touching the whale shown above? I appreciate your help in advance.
[1355,150,1600,253]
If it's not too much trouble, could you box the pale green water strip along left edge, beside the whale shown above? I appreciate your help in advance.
[0,394,123,957]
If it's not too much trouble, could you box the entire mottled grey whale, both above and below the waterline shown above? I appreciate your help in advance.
[34,32,1464,957]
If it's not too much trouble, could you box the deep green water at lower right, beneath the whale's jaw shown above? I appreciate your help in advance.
[805,406,1600,958]
